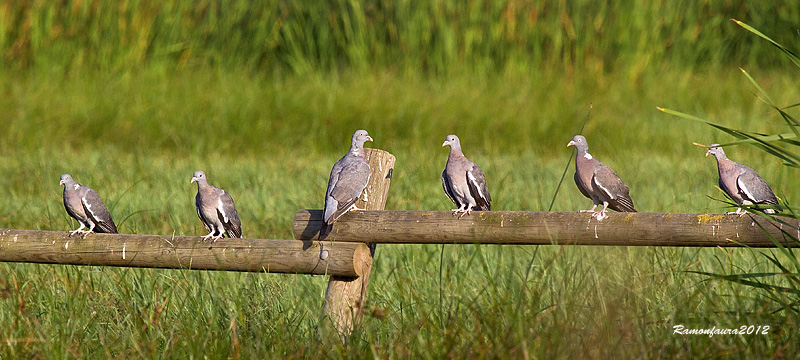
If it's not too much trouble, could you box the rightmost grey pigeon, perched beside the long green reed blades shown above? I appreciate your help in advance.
[706,144,778,215]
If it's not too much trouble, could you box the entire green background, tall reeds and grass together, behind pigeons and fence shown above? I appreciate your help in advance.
[0,1,800,359]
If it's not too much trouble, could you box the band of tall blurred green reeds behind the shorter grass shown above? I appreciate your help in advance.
[0,0,800,77]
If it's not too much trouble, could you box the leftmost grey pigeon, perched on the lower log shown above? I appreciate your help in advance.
[60,174,117,237]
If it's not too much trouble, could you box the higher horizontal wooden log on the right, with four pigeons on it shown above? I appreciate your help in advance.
[294,210,800,247]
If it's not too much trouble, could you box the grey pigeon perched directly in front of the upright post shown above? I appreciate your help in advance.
[319,130,372,240]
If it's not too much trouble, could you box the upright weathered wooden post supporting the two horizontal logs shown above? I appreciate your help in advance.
[321,148,395,341]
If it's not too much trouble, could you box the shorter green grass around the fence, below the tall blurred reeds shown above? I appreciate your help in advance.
[0,69,800,358]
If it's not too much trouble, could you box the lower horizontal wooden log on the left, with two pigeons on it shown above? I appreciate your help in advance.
[0,229,372,276]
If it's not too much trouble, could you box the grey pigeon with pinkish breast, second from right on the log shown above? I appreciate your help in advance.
[567,135,636,220]
